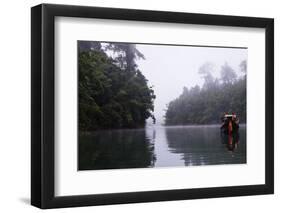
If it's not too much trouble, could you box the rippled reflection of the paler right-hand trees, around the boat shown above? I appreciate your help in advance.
[166,126,246,166]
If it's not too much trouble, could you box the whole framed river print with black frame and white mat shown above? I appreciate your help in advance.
[31,4,274,208]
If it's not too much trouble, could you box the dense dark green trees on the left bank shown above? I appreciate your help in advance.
[78,41,155,131]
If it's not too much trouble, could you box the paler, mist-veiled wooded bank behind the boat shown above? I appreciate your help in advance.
[165,61,247,125]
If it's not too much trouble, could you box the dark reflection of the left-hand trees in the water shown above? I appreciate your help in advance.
[78,129,156,170]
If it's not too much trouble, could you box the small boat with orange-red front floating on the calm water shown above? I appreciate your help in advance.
[221,112,239,134]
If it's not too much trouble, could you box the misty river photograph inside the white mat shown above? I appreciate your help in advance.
[77,41,247,170]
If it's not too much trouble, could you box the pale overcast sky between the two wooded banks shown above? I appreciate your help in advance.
[137,44,247,124]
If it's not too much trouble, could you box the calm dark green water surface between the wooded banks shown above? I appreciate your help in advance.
[78,125,246,170]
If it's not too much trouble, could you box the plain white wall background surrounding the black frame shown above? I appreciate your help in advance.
[0,0,276,213]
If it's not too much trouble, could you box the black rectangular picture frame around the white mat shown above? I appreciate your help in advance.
[31,4,274,209]
